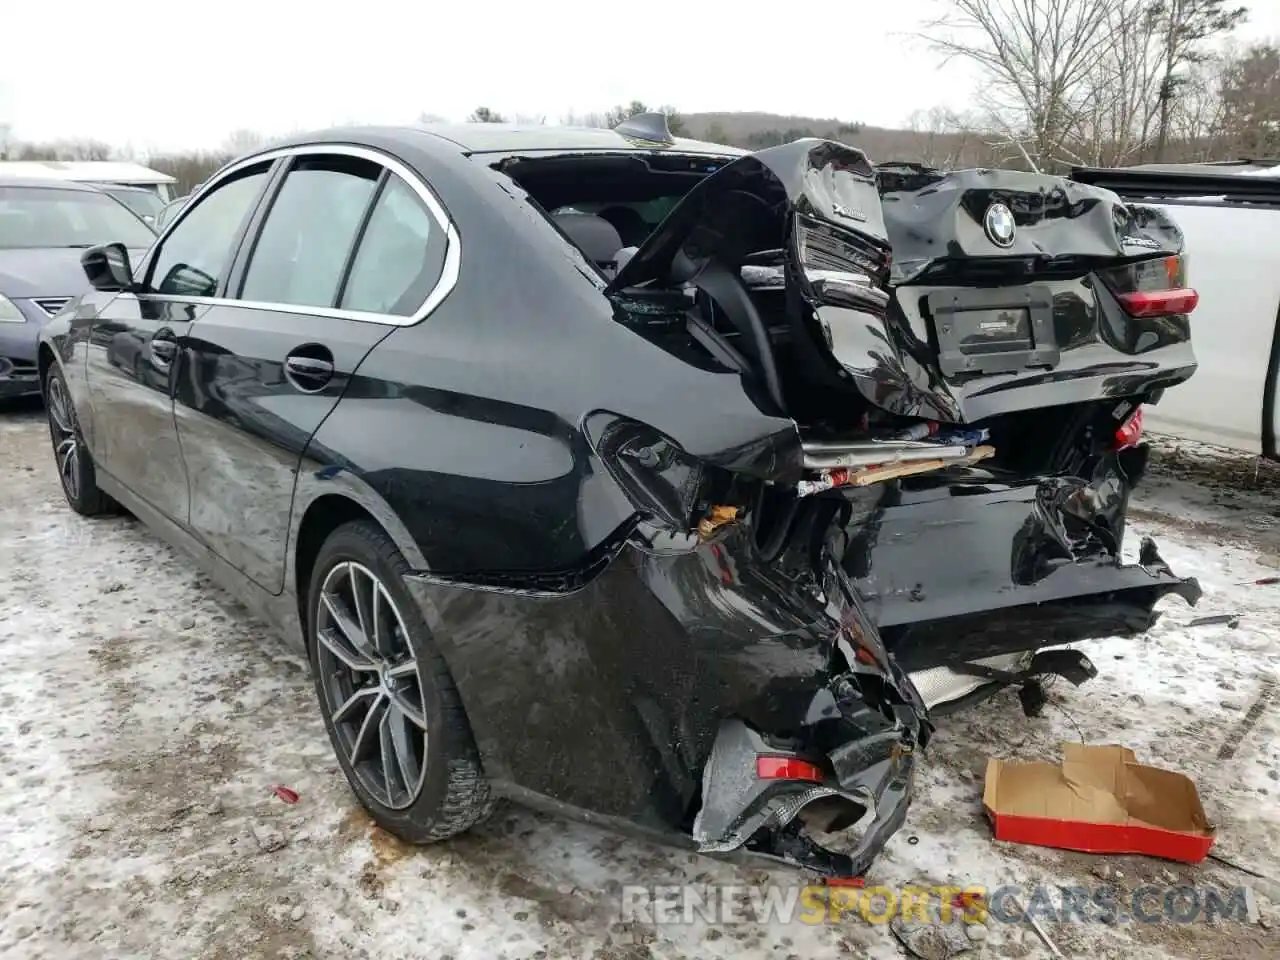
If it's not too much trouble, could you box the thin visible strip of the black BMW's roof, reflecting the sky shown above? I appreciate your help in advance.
[270,123,748,156]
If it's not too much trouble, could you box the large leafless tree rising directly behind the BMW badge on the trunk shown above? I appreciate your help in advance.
[924,0,1124,168]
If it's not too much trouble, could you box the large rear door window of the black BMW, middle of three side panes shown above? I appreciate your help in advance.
[239,156,383,307]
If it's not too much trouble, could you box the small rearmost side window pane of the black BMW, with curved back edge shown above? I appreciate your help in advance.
[339,174,445,316]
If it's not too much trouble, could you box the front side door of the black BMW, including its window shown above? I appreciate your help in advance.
[86,163,270,525]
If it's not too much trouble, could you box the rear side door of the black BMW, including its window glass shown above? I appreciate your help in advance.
[175,146,444,593]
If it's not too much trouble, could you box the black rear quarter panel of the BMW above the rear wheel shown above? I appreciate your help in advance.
[300,138,799,575]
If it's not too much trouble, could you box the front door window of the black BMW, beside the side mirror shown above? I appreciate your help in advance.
[150,164,270,297]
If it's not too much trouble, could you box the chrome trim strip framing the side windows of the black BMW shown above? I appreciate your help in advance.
[136,143,462,326]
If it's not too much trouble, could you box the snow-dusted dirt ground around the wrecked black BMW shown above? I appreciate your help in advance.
[0,410,1280,960]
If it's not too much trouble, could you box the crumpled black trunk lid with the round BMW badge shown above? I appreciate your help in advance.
[608,140,1196,424]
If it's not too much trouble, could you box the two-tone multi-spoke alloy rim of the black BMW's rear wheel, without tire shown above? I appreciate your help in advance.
[314,561,428,810]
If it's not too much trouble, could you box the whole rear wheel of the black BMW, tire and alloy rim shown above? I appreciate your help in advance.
[307,521,494,844]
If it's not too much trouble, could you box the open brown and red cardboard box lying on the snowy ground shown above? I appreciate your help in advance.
[982,744,1213,863]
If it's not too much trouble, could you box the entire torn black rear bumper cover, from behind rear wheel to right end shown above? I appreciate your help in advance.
[406,458,1199,876]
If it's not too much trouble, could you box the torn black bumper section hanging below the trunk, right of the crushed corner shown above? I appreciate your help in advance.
[844,470,1201,672]
